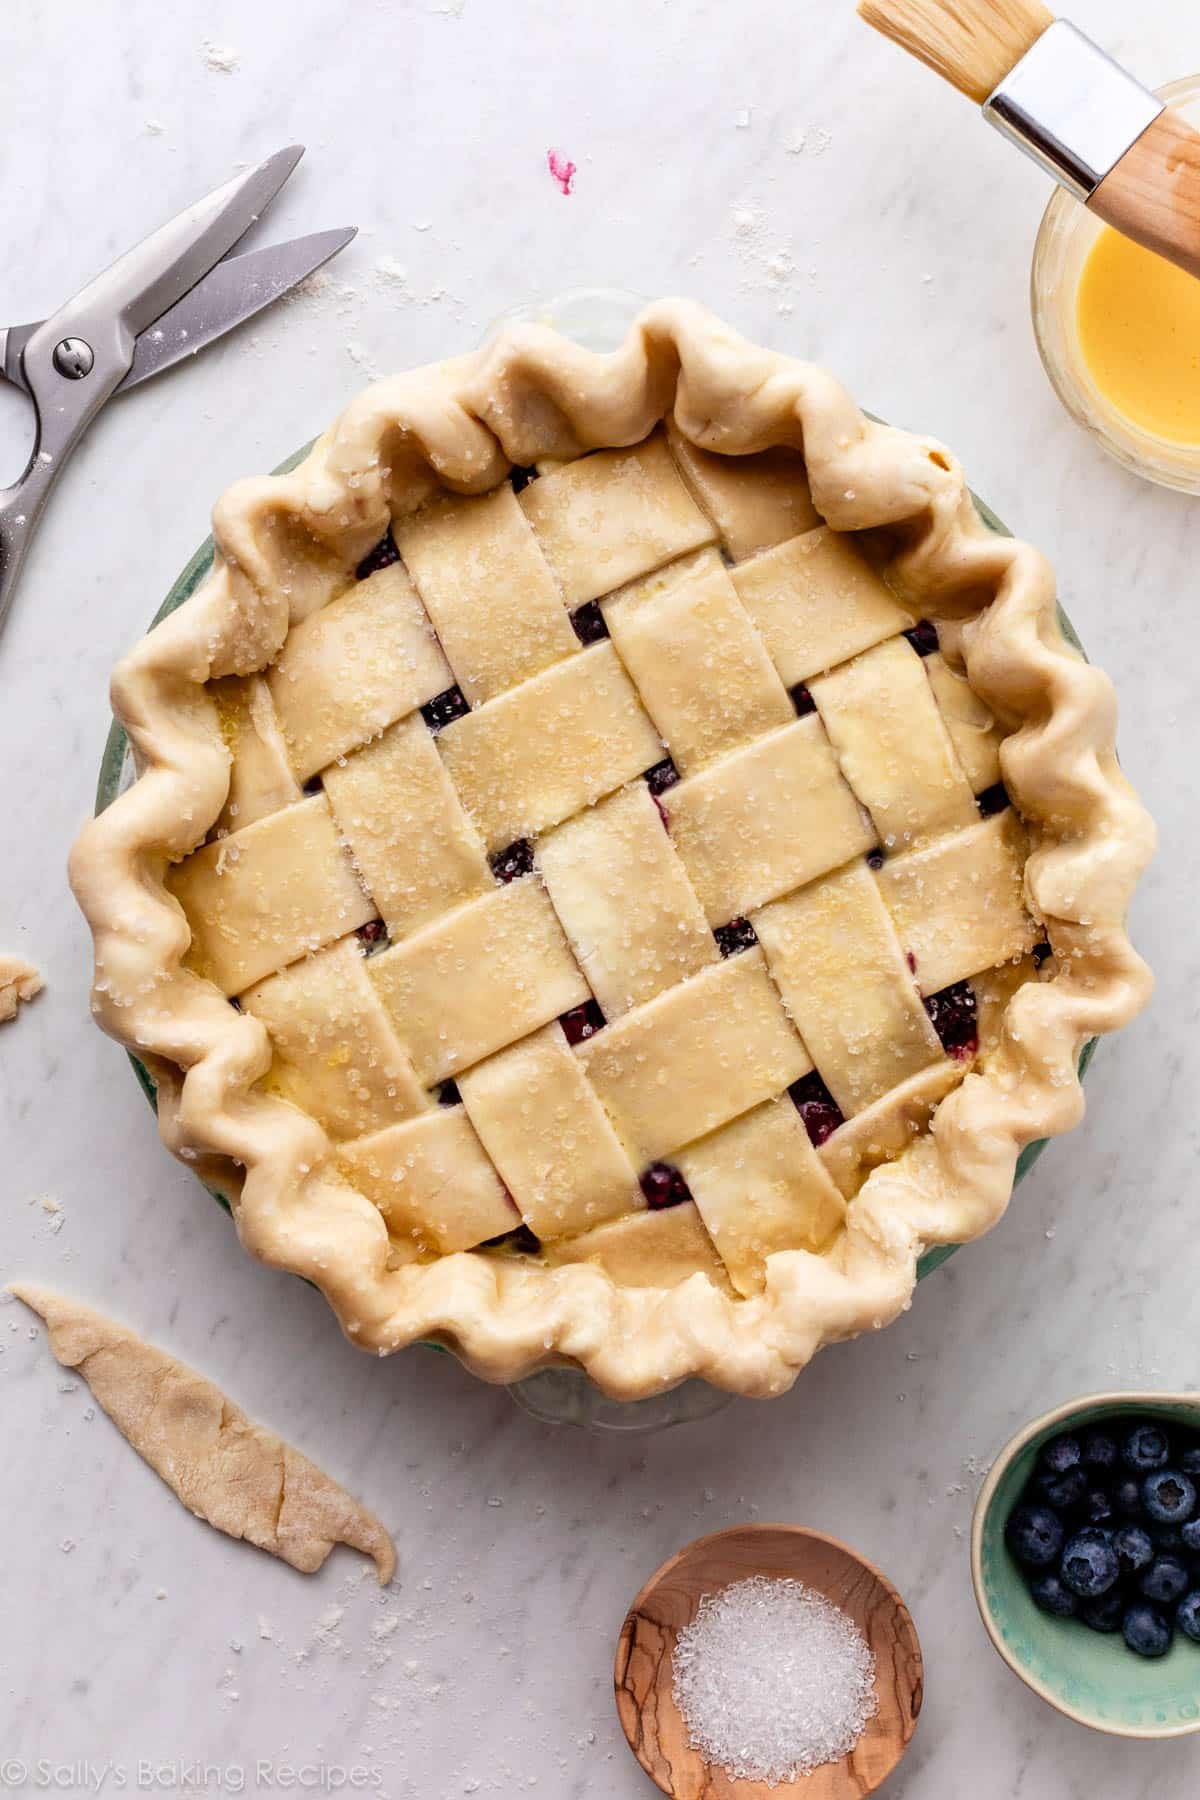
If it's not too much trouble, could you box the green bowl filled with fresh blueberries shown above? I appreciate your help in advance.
[972,1393,1200,1737]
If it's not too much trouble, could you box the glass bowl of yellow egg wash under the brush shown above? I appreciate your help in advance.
[1031,76,1200,493]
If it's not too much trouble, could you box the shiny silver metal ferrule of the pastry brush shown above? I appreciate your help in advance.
[984,18,1164,200]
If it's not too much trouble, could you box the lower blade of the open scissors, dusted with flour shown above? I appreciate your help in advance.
[117,225,358,392]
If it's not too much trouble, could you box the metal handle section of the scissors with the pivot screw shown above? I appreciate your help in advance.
[0,320,133,625]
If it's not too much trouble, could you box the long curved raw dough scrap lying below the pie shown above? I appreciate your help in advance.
[9,1282,396,1588]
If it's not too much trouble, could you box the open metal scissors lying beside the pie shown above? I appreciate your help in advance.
[0,144,356,640]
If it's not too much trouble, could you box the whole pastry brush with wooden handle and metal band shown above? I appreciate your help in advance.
[858,0,1200,275]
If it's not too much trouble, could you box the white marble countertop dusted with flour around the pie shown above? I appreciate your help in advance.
[0,0,1200,1800]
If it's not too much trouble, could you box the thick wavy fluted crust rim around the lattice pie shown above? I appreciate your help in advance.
[70,301,1153,1399]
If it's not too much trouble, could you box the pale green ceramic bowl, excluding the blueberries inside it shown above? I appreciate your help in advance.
[972,1393,1200,1737]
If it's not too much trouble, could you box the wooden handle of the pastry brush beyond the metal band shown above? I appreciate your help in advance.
[1088,110,1200,275]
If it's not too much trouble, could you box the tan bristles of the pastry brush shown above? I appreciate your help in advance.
[858,0,1054,106]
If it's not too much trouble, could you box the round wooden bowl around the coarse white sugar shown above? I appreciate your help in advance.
[613,1525,925,1800]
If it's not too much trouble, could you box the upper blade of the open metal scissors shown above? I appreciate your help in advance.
[42,144,304,352]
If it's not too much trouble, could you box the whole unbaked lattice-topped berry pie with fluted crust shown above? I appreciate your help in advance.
[72,302,1150,1397]
